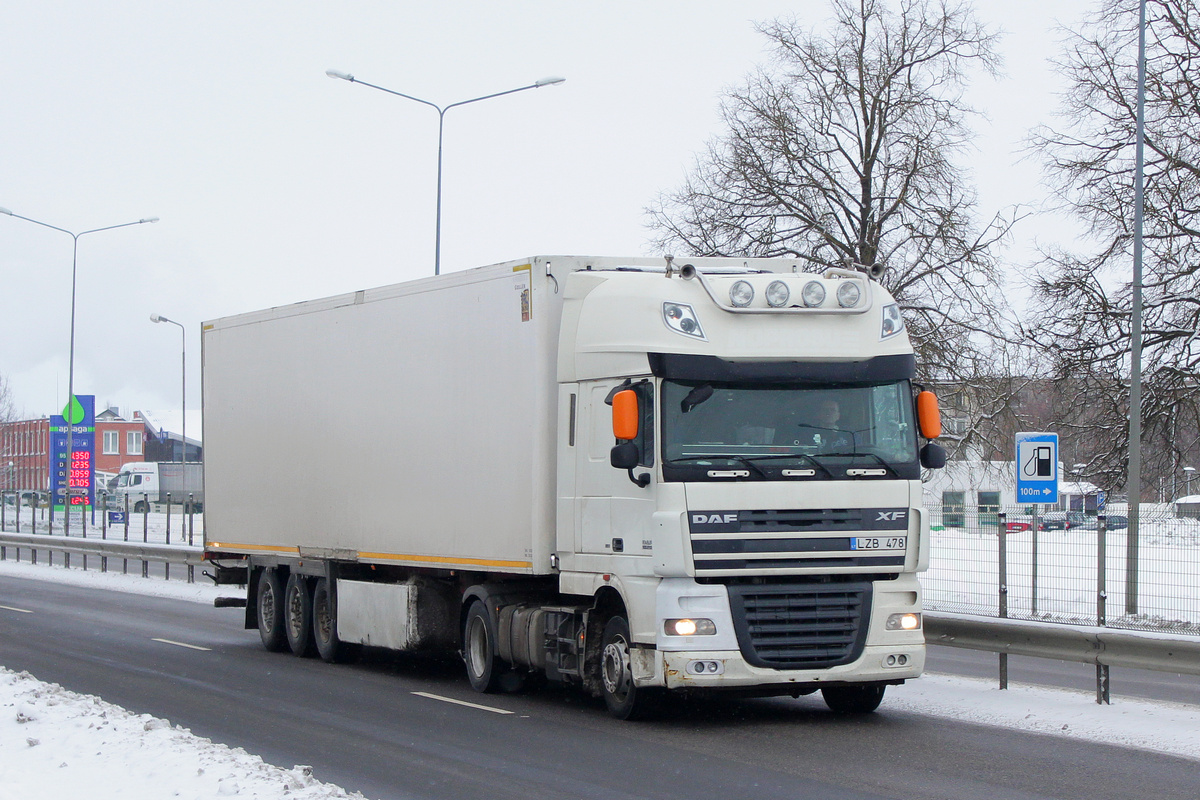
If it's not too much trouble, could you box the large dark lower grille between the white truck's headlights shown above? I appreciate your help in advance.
[728,583,871,669]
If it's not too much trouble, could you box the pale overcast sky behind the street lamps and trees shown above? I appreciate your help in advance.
[0,0,1092,437]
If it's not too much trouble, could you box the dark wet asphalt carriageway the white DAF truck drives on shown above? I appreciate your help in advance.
[0,577,1200,800]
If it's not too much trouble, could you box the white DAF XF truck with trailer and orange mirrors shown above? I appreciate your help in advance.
[202,257,944,718]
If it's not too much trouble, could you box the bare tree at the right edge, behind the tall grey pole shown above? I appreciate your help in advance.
[1032,0,1200,489]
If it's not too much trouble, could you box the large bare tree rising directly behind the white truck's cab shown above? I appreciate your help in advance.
[648,0,1018,453]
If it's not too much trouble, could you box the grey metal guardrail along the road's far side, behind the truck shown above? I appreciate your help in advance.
[0,531,1200,703]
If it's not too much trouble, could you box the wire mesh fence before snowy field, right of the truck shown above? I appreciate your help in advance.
[922,506,1200,636]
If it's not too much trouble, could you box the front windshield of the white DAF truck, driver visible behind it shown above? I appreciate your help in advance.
[662,380,920,481]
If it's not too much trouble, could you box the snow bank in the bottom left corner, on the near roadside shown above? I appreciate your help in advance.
[0,667,362,800]
